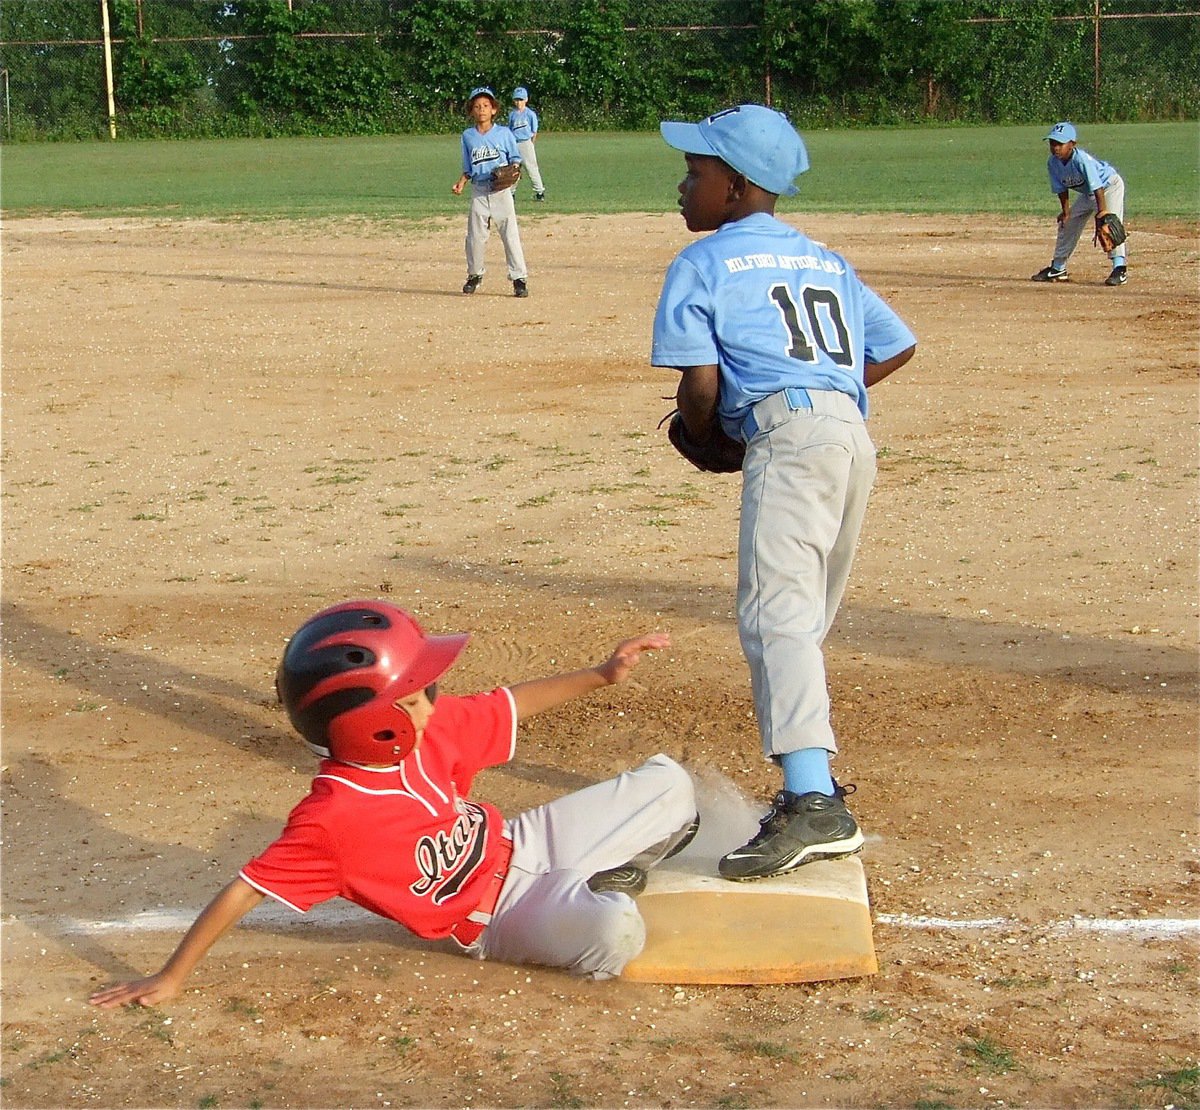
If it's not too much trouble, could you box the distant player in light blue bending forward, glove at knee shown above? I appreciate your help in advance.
[1032,120,1129,286]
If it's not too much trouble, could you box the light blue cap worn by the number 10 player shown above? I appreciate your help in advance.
[659,104,809,197]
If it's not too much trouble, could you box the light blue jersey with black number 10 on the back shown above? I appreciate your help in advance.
[650,212,916,424]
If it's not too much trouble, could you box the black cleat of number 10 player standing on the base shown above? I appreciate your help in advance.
[718,782,863,882]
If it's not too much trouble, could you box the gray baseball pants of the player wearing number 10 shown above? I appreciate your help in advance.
[738,390,875,758]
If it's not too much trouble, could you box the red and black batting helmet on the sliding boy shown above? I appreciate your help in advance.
[275,601,470,763]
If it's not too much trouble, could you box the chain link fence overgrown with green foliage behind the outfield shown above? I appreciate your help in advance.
[0,0,1200,139]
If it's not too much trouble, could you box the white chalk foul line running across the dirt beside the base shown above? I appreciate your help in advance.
[9,904,1200,937]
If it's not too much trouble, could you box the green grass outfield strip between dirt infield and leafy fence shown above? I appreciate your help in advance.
[0,122,1200,220]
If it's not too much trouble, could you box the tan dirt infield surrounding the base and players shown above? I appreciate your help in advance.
[7,215,1200,1110]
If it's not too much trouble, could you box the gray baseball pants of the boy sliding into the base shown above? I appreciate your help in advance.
[467,755,696,979]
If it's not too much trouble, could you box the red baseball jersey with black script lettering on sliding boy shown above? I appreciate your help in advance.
[240,688,517,940]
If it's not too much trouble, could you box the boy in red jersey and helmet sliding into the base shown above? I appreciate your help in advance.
[90,601,698,1008]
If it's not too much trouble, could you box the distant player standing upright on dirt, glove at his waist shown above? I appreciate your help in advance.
[451,86,529,296]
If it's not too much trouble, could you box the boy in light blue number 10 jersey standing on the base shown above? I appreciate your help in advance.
[650,104,916,881]
